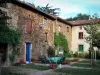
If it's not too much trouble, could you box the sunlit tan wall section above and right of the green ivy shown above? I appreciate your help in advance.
[54,21,72,50]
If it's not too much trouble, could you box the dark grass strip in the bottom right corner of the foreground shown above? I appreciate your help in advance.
[55,68,100,75]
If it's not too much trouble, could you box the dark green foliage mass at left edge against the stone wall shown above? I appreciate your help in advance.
[0,3,20,45]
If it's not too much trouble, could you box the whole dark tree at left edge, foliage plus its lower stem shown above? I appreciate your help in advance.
[0,0,20,65]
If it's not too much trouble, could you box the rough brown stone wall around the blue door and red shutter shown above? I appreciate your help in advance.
[8,4,54,59]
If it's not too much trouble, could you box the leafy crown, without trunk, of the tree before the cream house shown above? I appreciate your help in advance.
[84,22,100,48]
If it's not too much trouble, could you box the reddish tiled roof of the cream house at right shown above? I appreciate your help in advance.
[68,18,100,26]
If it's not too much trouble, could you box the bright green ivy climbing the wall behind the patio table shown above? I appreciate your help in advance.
[54,33,69,57]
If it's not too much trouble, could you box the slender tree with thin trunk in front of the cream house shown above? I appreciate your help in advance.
[84,15,100,65]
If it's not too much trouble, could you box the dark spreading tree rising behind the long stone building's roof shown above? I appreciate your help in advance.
[37,4,60,16]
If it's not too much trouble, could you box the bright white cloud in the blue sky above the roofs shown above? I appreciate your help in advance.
[34,0,87,18]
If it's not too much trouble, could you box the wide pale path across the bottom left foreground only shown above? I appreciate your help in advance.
[2,66,64,75]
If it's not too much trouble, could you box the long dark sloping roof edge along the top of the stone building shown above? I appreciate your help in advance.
[7,0,71,26]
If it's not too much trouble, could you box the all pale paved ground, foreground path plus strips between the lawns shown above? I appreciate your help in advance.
[2,59,91,75]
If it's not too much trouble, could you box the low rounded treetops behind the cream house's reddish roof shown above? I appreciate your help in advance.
[66,13,90,21]
